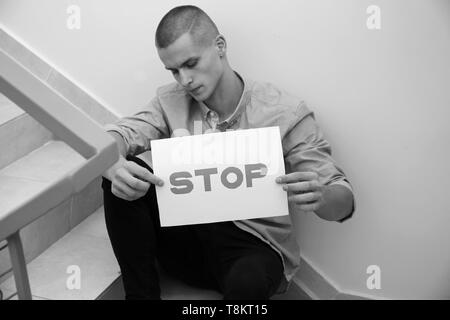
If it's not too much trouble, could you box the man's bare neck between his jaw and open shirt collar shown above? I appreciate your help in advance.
[205,67,244,121]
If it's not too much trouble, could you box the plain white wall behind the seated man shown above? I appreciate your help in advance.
[0,0,450,299]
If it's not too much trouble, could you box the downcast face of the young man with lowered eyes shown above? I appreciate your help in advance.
[158,33,223,101]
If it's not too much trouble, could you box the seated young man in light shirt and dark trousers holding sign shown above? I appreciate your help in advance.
[103,6,353,299]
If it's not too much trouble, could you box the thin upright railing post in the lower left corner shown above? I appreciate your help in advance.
[8,231,32,300]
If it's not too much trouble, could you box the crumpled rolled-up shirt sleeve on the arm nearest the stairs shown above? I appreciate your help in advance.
[104,98,169,156]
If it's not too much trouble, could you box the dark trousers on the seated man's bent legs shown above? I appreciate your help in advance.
[102,157,283,300]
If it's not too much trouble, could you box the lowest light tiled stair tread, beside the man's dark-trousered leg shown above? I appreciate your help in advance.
[0,209,119,300]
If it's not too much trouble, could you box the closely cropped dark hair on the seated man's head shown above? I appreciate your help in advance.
[155,6,219,49]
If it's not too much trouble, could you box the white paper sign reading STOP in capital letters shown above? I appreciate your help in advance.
[151,127,289,227]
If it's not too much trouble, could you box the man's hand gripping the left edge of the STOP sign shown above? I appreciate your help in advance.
[110,158,164,201]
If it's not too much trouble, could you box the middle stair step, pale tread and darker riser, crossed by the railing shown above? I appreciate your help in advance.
[0,141,94,282]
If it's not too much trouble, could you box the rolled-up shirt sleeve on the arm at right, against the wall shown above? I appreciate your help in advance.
[283,106,355,222]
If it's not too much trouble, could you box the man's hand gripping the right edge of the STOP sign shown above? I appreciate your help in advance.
[276,172,325,212]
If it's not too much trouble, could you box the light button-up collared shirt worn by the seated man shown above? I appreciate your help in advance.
[106,74,354,292]
